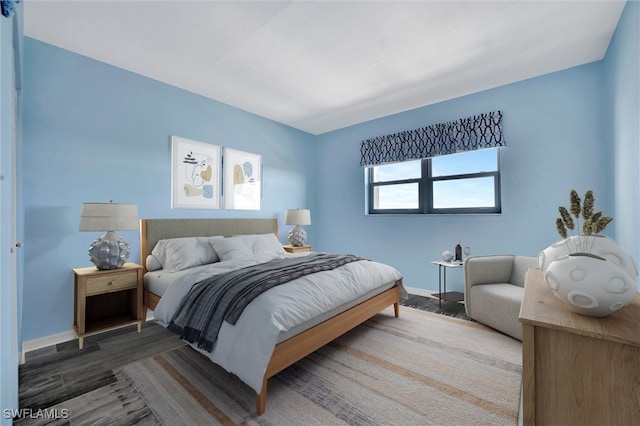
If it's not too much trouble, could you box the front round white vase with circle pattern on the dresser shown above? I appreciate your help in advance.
[544,255,637,317]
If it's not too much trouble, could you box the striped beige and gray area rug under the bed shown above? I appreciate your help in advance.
[120,308,521,425]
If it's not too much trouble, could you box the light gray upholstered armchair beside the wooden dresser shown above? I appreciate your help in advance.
[464,255,538,340]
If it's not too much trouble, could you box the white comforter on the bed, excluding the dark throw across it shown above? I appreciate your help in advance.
[154,251,406,393]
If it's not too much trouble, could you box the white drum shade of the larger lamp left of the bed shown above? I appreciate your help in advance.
[79,203,139,231]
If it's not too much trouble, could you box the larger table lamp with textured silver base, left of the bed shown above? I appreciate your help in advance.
[79,201,139,269]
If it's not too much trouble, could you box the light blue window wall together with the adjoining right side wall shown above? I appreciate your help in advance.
[316,1,640,291]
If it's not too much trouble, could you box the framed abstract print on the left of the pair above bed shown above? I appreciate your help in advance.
[171,136,221,209]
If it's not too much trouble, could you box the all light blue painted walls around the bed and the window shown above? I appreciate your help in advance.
[21,2,640,340]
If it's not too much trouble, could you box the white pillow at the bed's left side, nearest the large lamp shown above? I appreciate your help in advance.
[147,237,223,272]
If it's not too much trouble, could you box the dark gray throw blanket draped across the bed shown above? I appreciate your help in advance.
[167,253,364,352]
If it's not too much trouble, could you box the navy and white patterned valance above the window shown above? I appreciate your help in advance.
[360,111,506,166]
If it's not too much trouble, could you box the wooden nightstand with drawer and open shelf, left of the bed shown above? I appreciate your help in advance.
[73,263,146,349]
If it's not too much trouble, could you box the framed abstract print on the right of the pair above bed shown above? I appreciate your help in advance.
[223,148,262,210]
